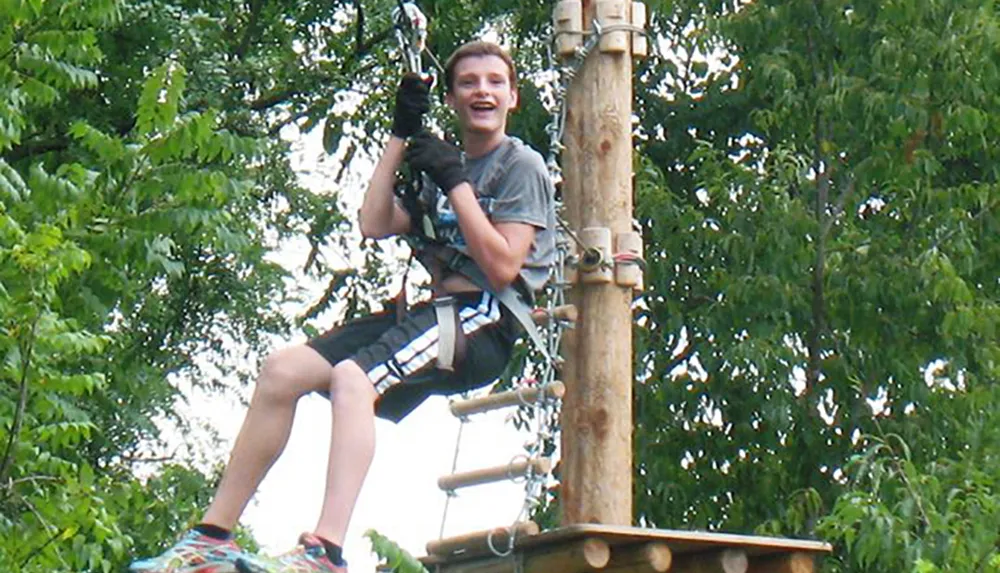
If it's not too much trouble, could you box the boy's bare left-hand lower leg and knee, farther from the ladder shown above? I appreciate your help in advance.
[202,345,338,529]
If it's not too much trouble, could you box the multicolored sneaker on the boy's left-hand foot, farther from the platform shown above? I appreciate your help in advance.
[128,529,248,573]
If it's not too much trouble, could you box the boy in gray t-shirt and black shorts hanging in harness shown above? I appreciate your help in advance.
[130,42,555,573]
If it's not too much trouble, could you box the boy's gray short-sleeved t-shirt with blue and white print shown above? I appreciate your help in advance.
[421,137,556,292]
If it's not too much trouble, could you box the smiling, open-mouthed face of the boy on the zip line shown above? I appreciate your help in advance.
[445,54,517,139]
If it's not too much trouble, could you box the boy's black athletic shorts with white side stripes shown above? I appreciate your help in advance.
[306,292,518,422]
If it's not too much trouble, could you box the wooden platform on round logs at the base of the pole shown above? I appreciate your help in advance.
[420,524,832,573]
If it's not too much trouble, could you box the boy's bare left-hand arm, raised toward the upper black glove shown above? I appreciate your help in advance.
[358,135,411,239]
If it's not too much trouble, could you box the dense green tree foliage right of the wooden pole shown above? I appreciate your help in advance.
[636,0,1000,571]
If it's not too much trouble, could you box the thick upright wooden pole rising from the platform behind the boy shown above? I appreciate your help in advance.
[560,0,632,525]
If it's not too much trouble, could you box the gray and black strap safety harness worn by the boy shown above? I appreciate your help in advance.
[396,137,551,372]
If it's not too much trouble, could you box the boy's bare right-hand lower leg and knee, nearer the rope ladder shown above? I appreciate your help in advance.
[316,360,378,546]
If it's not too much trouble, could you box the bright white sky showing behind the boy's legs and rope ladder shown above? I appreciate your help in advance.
[172,123,530,571]
